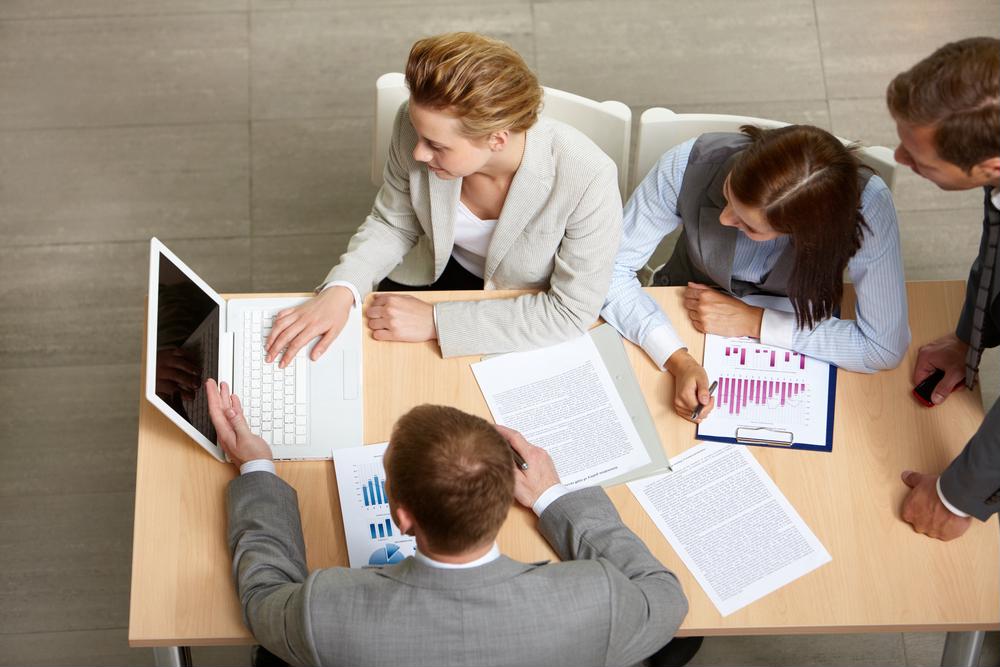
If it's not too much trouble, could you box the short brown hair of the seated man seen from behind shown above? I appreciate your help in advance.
[383,405,514,554]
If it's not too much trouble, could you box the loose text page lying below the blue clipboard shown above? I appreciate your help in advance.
[628,443,830,616]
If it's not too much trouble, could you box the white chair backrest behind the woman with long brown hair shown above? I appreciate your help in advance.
[629,107,896,192]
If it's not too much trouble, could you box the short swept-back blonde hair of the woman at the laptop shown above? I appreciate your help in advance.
[406,32,542,139]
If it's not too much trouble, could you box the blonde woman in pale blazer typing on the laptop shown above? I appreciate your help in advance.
[267,33,622,366]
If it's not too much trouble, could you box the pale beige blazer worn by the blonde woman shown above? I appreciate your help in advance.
[324,104,622,357]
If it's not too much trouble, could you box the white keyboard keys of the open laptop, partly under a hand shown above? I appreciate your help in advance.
[240,311,309,445]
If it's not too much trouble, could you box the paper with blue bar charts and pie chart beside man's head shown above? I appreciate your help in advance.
[333,442,416,567]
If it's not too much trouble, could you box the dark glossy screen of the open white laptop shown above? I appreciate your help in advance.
[155,253,219,443]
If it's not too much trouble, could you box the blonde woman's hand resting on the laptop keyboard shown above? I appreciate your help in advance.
[266,286,354,368]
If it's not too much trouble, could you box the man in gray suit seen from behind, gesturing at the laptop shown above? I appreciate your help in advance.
[207,380,687,667]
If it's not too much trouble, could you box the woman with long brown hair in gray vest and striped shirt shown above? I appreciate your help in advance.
[601,125,910,420]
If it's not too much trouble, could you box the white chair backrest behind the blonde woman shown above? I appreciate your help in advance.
[371,72,632,200]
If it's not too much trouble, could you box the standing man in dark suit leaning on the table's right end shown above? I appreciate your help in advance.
[886,37,1000,540]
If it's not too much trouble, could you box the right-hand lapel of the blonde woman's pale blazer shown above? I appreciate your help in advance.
[483,118,555,283]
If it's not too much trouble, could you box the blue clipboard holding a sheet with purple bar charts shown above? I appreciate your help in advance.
[698,334,836,450]
